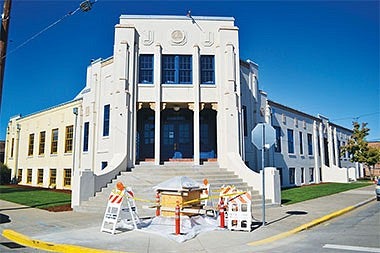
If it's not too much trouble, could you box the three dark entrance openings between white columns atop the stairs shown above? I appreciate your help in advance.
[136,108,217,162]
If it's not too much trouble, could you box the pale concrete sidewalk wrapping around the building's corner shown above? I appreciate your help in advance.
[0,185,375,252]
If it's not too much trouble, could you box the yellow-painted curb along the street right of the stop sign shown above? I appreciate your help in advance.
[247,206,355,246]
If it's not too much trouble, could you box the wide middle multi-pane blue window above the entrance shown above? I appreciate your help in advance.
[162,55,192,84]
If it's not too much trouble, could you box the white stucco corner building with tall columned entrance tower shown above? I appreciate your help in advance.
[2,15,360,210]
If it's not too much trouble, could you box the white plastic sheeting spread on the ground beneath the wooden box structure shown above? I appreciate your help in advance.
[118,215,224,243]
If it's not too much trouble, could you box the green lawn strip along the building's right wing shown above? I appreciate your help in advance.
[281,181,372,205]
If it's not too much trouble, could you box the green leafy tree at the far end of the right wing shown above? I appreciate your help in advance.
[341,122,380,180]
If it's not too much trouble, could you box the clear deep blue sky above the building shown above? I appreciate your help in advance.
[0,0,380,141]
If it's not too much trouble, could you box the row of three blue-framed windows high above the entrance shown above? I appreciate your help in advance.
[139,54,215,84]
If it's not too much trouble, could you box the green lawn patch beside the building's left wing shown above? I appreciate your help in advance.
[0,185,71,209]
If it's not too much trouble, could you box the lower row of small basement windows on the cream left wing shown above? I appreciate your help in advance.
[17,169,71,187]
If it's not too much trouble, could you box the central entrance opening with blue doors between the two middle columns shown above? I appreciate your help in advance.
[161,109,194,161]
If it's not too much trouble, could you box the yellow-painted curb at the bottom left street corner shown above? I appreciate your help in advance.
[2,229,127,253]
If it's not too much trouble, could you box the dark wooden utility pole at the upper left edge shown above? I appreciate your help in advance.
[0,0,12,111]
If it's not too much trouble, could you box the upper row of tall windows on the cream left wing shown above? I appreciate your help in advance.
[24,125,74,157]
